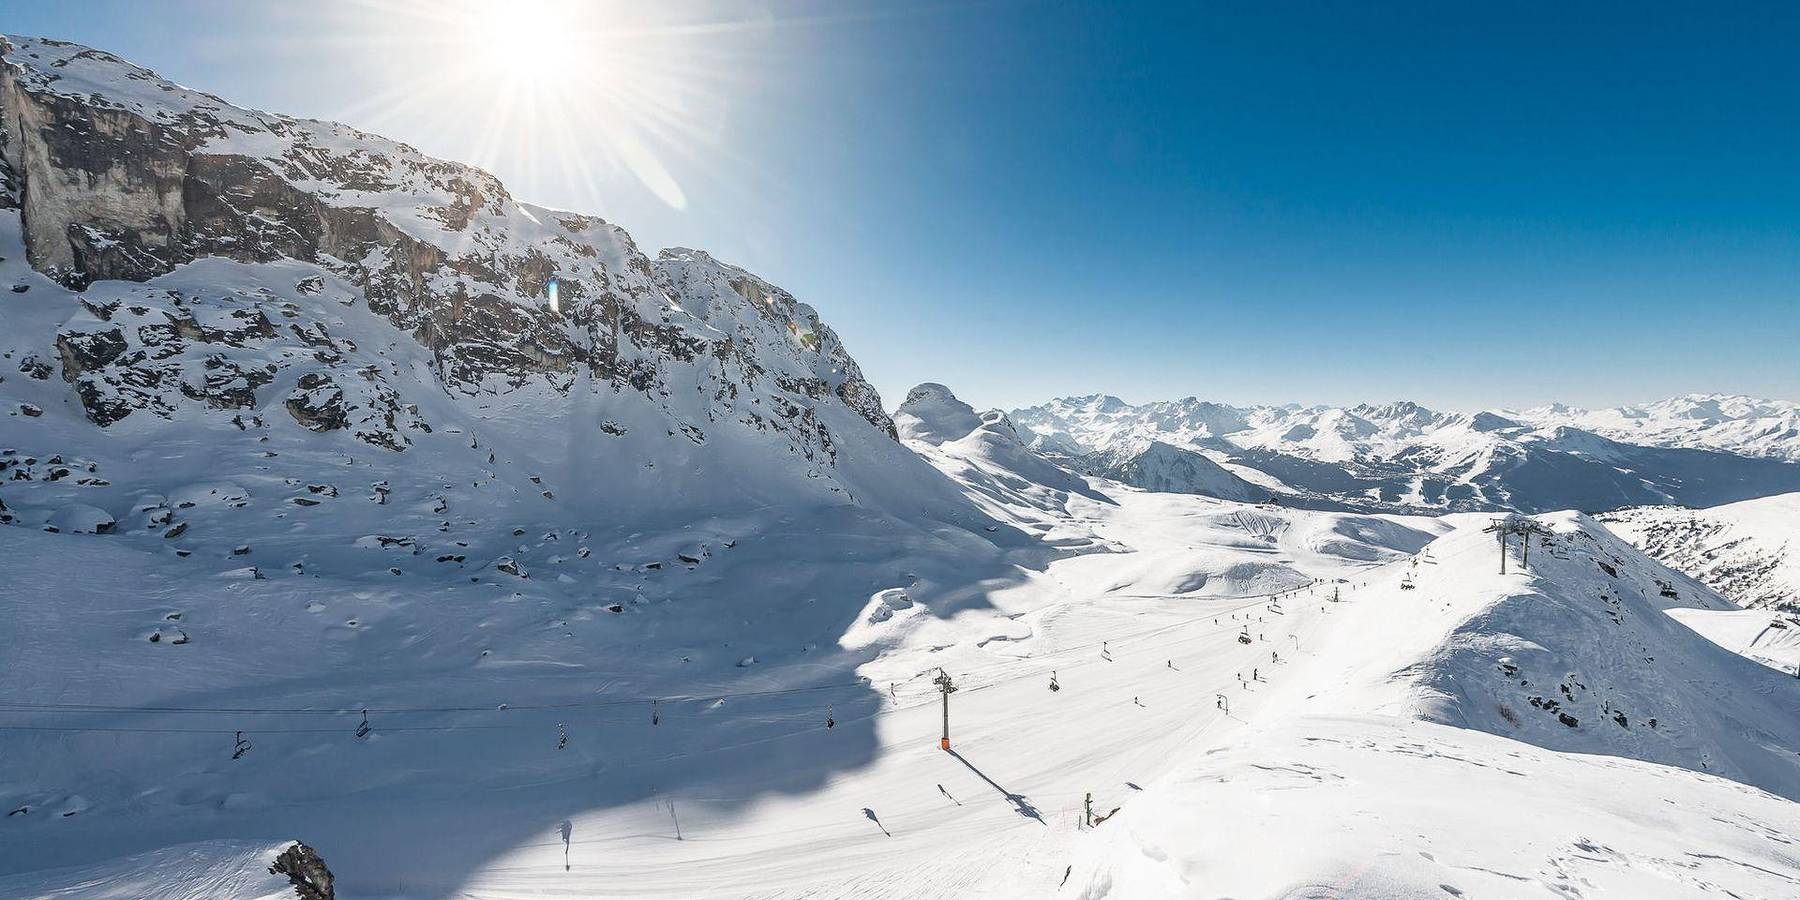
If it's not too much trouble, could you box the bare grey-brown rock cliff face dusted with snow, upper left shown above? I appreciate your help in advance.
[0,38,893,463]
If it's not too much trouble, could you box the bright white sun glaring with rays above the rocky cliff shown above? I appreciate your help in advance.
[344,0,748,209]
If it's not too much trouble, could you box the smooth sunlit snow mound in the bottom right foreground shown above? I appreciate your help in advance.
[1057,718,1796,900]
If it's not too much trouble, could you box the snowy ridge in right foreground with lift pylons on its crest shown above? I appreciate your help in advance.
[1060,515,1800,900]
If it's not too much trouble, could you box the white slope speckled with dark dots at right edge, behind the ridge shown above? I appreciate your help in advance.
[1602,493,1800,610]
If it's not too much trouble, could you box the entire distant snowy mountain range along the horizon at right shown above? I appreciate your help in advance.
[1010,394,1800,511]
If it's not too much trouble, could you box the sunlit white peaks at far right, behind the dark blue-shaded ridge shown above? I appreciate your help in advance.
[1516,394,1800,463]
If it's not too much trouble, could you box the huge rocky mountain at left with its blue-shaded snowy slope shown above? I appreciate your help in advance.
[0,38,1036,896]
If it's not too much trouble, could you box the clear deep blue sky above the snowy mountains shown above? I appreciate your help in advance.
[0,0,1800,409]
